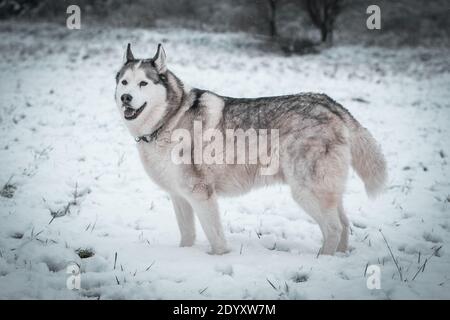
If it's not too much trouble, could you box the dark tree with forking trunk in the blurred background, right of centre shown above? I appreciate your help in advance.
[306,0,342,44]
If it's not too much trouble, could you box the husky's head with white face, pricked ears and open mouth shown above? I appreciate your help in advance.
[115,44,168,134]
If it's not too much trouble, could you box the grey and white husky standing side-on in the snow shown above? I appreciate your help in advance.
[115,44,387,255]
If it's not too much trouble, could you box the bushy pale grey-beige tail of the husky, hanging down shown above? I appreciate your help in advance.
[351,125,387,197]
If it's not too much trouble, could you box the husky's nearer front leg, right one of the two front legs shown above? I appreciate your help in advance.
[185,191,230,254]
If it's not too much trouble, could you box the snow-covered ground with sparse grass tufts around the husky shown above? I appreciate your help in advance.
[0,22,450,299]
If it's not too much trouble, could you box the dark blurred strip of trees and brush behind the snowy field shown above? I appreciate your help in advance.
[0,0,450,53]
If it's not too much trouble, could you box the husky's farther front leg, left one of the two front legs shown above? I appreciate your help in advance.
[171,195,195,247]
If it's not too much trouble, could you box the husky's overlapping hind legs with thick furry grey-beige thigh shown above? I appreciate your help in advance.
[283,125,351,255]
